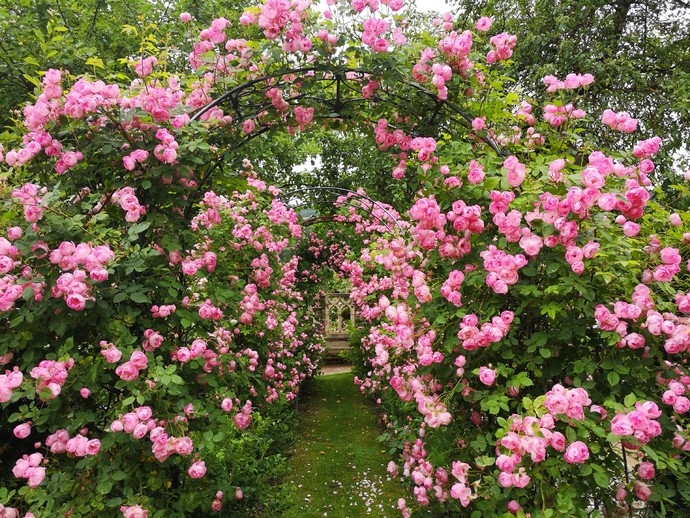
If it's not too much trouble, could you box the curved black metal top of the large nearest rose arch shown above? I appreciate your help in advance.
[192,65,503,155]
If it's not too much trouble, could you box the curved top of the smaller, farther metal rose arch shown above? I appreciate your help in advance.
[279,186,404,234]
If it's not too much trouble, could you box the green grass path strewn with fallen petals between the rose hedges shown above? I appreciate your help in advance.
[284,373,405,518]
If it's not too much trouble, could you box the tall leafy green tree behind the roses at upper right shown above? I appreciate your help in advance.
[453,0,690,178]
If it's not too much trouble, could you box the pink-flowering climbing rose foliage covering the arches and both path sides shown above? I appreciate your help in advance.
[0,0,690,517]
